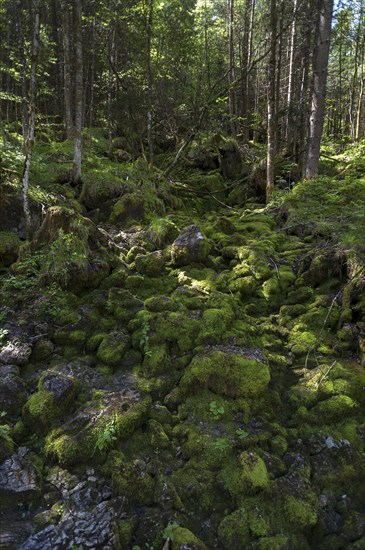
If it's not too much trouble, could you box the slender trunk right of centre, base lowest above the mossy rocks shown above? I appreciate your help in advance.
[266,0,277,202]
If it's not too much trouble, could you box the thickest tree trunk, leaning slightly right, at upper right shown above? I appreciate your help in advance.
[304,0,333,178]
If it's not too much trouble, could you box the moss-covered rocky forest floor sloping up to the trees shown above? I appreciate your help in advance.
[0,136,365,550]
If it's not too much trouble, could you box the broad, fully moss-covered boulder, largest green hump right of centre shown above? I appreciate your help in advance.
[180,351,270,398]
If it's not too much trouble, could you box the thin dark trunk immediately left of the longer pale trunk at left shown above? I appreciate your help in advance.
[62,0,73,139]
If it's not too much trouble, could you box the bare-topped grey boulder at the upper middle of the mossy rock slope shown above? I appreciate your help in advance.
[171,224,210,266]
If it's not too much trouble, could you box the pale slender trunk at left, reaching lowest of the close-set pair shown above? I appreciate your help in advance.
[72,0,83,183]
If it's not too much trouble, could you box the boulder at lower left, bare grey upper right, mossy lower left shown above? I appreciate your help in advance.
[23,371,77,434]
